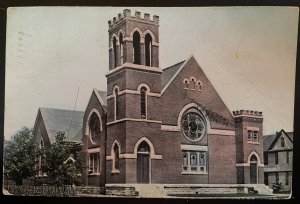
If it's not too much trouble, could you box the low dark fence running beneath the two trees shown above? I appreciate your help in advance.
[4,185,77,197]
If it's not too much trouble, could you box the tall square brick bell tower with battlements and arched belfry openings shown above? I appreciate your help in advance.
[106,9,162,183]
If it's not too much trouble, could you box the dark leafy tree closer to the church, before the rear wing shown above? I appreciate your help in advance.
[42,131,81,185]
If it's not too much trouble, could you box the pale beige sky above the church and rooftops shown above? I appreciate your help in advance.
[4,7,299,139]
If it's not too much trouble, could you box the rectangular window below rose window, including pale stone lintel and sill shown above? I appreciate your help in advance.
[181,145,208,175]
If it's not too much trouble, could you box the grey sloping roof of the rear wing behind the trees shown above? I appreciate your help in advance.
[40,108,84,143]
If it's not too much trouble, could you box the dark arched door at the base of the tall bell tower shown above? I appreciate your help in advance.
[136,141,150,183]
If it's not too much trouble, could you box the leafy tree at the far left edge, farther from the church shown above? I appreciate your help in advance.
[4,127,38,185]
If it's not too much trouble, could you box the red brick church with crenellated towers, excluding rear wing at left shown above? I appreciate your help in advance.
[82,9,264,190]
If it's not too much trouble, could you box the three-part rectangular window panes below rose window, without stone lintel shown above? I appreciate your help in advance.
[182,150,207,173]
